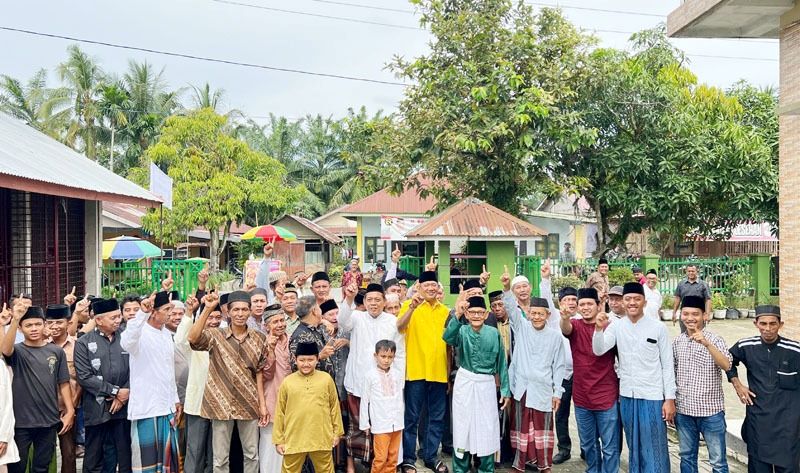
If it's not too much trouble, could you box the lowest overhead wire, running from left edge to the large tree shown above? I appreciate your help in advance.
[0,25,408,86]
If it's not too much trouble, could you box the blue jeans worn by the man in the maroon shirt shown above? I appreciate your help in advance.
[575,402,621,473]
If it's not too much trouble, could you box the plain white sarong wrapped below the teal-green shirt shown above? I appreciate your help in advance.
[452,368,500,458]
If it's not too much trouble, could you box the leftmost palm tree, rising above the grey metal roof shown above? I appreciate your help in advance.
[0,69,71,139]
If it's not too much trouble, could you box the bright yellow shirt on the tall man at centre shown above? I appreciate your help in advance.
[399,300,450,383]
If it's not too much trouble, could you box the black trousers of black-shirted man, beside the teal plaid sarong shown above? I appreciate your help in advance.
[83,419,131,473]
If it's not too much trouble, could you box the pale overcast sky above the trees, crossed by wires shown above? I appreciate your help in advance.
[0,0,778,120]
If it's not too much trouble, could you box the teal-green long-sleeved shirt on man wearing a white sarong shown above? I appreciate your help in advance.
[442,317,511,397]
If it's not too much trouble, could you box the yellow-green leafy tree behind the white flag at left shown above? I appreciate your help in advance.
[142,109,300,271]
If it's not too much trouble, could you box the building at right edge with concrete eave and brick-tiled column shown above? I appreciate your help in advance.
[667,0,800,338]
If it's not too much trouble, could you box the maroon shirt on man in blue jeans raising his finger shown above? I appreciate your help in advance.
[567,319,619,411]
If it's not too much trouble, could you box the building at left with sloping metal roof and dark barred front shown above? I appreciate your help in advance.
[0,113,161,305]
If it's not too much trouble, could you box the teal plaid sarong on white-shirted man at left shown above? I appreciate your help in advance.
[131,414,178,473]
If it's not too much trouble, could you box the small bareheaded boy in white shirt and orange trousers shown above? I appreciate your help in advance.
[359,340,405,473]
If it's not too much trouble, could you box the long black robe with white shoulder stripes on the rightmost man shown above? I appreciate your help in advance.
[727,336,800,468]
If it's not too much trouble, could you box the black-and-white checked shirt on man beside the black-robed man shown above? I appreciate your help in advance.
[672,330,732,417]
